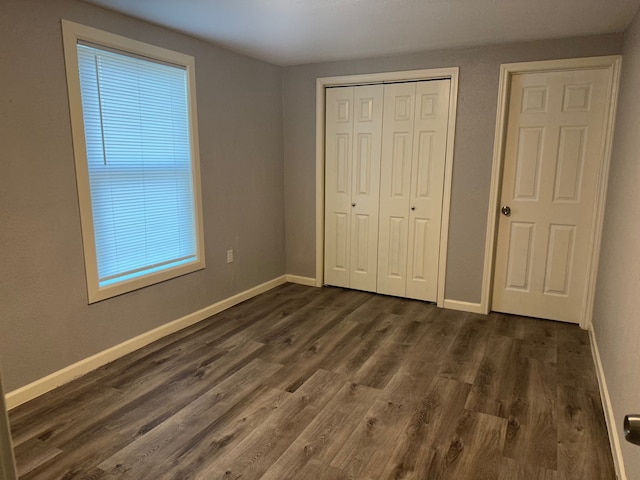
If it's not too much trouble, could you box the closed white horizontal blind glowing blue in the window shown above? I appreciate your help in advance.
[77,43,198,287]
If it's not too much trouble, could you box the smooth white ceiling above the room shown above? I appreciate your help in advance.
[85,0,640,65]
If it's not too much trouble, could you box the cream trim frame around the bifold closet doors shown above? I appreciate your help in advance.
[315,67,459,307]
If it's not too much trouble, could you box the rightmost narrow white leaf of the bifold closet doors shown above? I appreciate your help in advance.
[406,80,451,302]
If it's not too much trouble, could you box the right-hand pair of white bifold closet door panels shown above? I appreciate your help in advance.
[377,80,451,302]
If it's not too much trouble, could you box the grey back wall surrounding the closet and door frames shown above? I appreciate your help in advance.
[284,34,622,303]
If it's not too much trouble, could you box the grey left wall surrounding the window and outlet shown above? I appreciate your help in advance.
[0,0,285,391]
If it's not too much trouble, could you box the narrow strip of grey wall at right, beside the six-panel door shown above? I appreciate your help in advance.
[593,6,640,480]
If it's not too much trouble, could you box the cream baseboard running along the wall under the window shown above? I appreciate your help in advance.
[5,275,288,409]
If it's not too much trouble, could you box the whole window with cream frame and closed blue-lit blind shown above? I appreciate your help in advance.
[62,21,204,303]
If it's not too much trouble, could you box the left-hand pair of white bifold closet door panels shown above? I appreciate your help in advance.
[324,85,383,292]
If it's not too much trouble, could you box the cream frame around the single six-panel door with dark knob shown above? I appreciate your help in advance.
[481,55,622,328]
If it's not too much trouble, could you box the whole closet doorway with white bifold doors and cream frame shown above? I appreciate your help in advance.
[316,68,458,306]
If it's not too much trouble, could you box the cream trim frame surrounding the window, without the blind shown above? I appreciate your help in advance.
[62,20,205,303]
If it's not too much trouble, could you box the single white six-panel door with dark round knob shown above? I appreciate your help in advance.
[492,69,610,323]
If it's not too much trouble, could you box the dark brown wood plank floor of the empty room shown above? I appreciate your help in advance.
[10,284,615,480]
